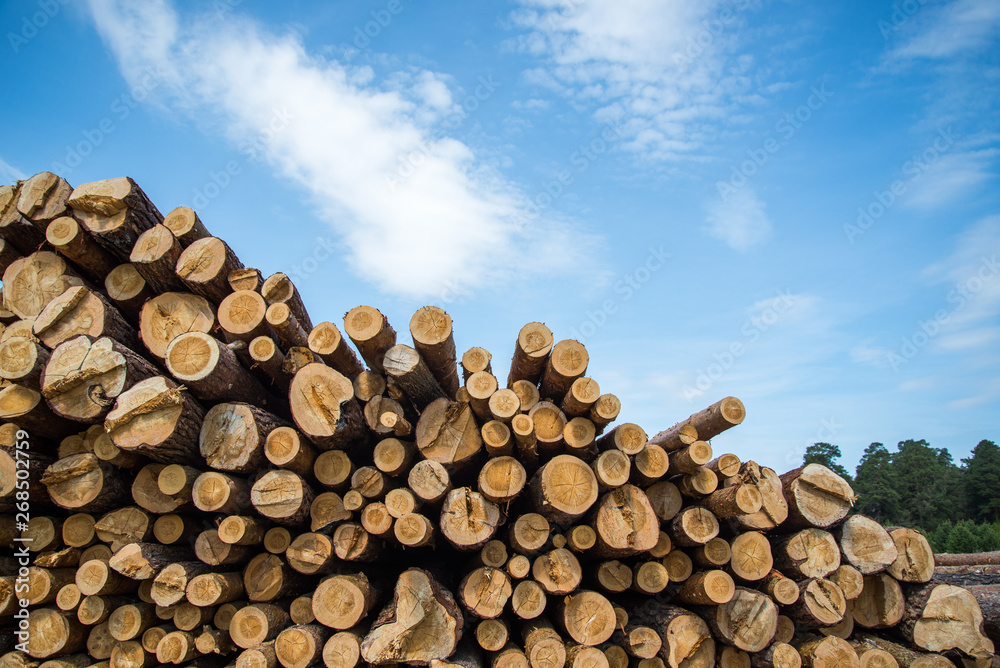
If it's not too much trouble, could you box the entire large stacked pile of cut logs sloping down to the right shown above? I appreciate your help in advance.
[0,173,998,668]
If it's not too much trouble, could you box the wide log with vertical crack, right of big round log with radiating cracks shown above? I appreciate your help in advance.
[588,480,660,558]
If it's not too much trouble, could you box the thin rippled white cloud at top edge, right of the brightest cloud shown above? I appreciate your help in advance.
[513,0,753,160]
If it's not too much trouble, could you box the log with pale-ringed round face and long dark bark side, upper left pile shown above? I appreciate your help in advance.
[165,332,284,412]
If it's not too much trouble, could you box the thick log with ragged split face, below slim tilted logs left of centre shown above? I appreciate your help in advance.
[289,363,368,450]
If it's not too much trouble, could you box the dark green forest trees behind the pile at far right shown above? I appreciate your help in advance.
[804,440,1000,554]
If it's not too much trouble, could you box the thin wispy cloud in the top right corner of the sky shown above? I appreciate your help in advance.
[887,0,1000,61]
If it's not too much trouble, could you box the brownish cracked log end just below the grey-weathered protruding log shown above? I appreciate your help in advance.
[416,398,483,470]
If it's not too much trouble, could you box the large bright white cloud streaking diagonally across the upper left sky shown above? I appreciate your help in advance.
[90,0,587,298]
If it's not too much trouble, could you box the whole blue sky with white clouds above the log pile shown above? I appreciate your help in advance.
[0,0,1000,471]
